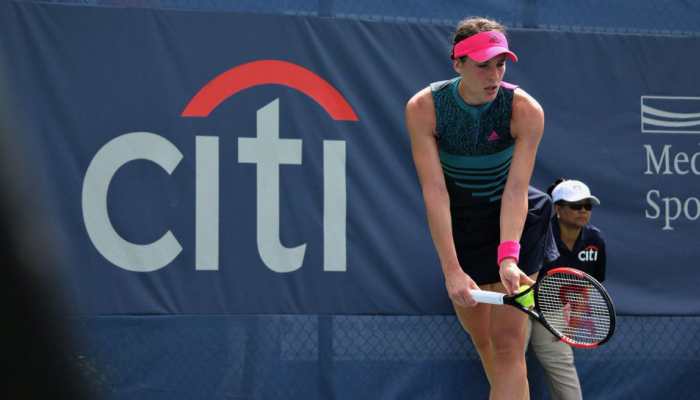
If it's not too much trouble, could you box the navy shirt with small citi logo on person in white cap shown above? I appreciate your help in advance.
[540,222,605,282]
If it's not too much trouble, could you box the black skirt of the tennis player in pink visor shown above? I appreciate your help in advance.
[452,186,559,285]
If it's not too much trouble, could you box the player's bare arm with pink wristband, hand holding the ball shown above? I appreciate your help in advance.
[500,89,544,293]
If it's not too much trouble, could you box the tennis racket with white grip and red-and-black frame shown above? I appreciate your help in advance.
[470,267,615,348]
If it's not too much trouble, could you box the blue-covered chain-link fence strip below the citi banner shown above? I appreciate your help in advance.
[75,315,700,400]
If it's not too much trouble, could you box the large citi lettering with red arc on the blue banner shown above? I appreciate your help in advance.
[82,60,358,273]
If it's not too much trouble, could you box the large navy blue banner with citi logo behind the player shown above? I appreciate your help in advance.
[0,2,700,315]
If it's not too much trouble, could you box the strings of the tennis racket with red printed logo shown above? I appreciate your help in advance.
[537,273,611,344]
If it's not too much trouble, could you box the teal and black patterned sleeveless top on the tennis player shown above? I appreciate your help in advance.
[430,77,517,208]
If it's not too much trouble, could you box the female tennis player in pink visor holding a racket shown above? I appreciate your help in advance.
[406,18,557,400]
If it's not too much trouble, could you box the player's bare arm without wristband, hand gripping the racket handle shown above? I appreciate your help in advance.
[406,88,477,306]
